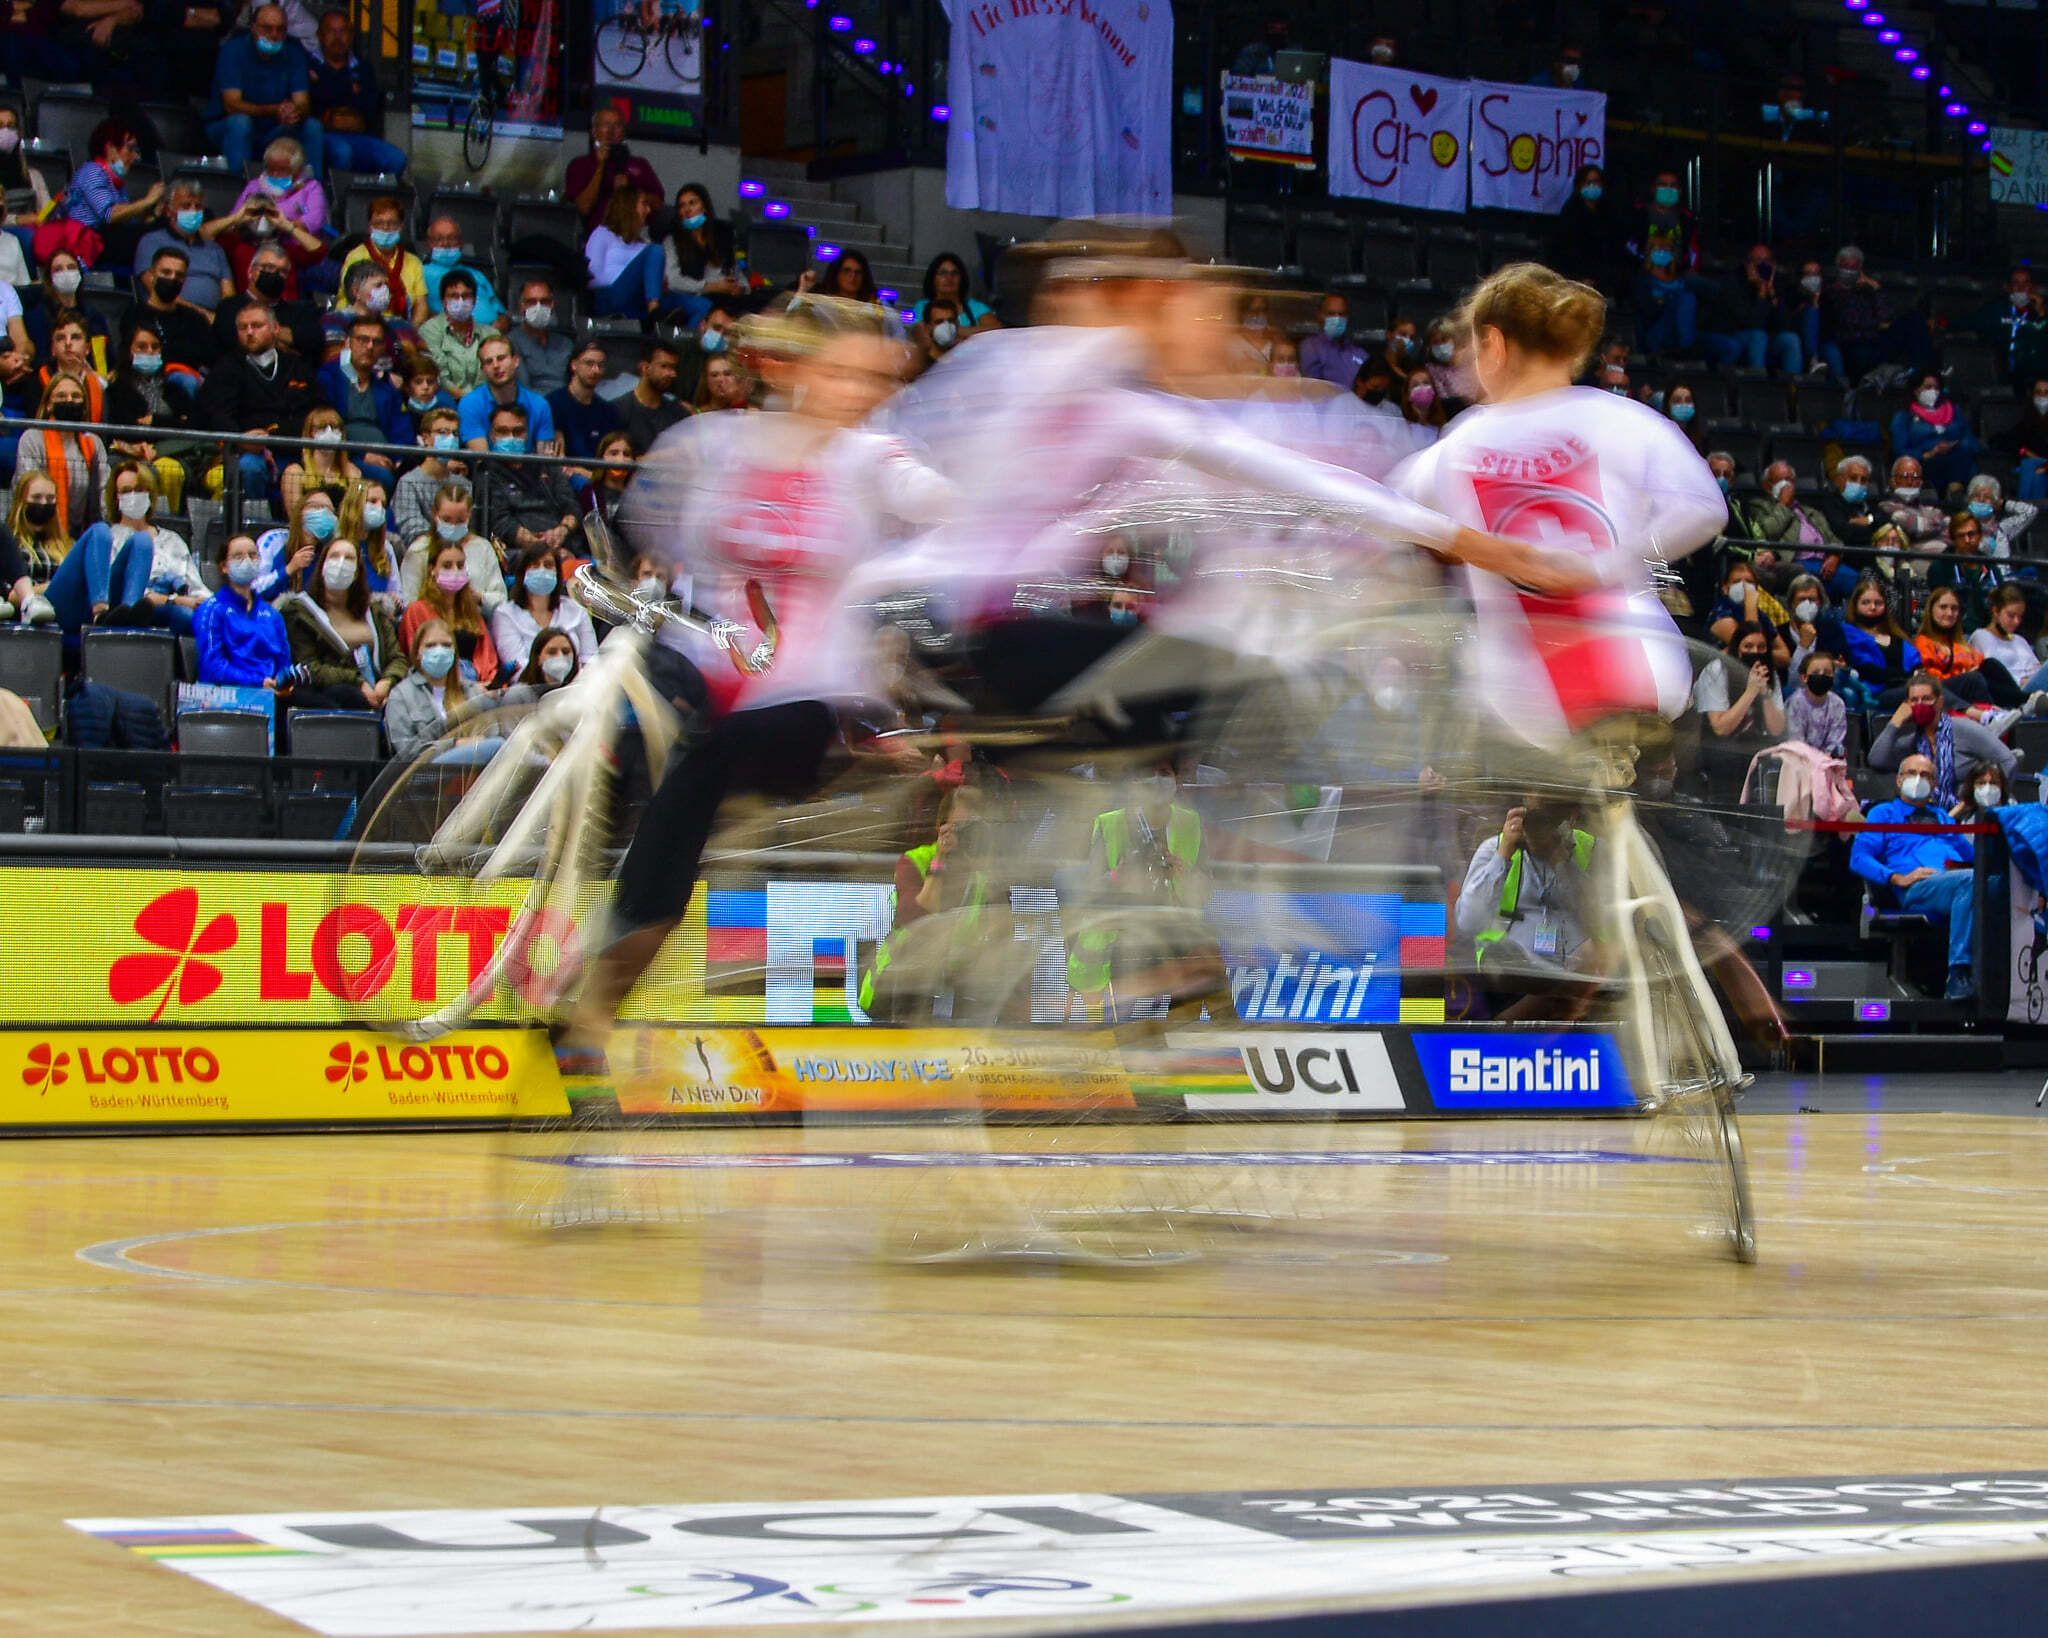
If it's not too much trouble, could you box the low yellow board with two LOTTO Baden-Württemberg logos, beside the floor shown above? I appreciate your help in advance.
[0,1030,569,1126]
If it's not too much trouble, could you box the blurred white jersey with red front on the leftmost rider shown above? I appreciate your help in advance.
[625,414,952,710]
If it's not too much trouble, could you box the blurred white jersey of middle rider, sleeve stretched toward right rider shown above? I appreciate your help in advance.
[872,326,1458,618]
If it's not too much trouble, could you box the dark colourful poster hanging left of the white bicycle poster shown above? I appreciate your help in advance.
[412,0,561,172]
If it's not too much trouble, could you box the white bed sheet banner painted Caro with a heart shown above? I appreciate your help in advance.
[1329,57,1473,211]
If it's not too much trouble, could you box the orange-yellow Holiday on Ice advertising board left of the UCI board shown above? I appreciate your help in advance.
[610,1028,1133,1114]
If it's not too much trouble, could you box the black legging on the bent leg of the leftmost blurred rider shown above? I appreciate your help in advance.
[612,700,840,938]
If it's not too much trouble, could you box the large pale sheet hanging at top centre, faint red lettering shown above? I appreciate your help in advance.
[946,0,1174,217]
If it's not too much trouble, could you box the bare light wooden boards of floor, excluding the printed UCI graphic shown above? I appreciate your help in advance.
[12,1114,2048,1636]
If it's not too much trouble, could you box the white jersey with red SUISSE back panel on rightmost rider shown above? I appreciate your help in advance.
[1395,387,1726,745]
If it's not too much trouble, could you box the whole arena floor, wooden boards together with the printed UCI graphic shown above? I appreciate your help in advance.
[12,1077,2048,1636]
